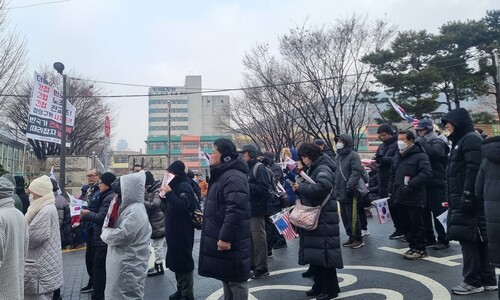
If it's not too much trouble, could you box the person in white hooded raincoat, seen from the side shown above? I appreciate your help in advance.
[101,171,151,299]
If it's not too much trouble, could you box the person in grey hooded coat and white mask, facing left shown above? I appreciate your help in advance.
[335,134,366,249]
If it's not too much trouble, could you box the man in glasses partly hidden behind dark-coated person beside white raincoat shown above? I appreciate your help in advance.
[80,169,101,293]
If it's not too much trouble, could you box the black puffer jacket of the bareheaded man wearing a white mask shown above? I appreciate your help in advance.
[389,144,432,207]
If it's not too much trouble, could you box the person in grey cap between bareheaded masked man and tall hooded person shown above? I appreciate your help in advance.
[415,118,450,250]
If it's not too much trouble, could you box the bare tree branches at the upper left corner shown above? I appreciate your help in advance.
[0,0,26,109]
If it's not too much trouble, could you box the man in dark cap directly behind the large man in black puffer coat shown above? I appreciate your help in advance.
[238,145,274,279]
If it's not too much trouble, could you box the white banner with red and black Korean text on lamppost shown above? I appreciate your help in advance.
[26,72,76,147]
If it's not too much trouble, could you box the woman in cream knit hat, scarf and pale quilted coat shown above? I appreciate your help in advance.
[24,175,63,300]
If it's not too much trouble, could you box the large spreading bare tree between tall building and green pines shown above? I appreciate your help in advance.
[220,16,394,149]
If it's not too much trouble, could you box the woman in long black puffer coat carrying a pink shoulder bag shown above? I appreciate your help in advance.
[292,143,344,300]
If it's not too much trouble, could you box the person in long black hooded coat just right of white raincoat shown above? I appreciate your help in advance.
[162,160,197,300]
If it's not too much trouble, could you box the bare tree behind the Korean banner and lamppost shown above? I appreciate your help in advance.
[1,68,116,160]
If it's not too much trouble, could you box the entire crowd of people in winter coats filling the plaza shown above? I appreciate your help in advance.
[0,109,500,300]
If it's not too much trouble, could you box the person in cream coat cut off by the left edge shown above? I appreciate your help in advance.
[0,177,28,299]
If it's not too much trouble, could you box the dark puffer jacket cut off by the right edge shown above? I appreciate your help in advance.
[476,136,500,268]
